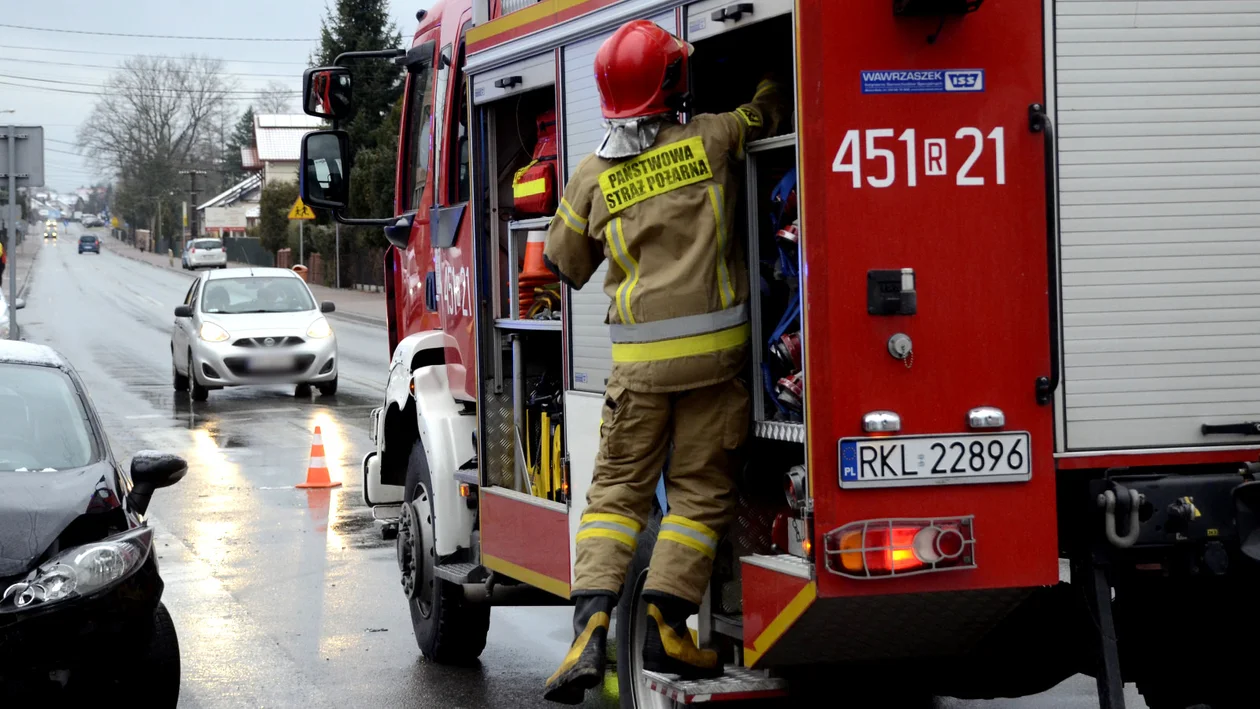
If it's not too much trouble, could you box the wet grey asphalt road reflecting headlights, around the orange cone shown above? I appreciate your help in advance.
[20,225,1143,709]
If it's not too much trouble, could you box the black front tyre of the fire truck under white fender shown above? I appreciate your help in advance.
[396,441,490,665]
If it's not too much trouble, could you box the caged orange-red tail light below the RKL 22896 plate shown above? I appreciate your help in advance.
[823,515,975,578]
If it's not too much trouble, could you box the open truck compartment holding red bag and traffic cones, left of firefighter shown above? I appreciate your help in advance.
[474,69,567,503]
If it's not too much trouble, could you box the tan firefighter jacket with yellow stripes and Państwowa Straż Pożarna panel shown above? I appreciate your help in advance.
[546,82,780,392]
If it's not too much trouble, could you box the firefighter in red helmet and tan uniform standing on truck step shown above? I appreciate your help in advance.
[544,20,781,704]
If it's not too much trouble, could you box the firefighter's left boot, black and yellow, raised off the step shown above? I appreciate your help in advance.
[543,592,617,704]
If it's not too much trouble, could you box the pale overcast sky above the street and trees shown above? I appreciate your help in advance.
[0,0,432,191]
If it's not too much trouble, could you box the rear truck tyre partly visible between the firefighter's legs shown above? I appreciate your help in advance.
[615,506,679,709]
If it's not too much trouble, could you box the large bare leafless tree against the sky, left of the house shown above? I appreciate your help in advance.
[78,55,231,241]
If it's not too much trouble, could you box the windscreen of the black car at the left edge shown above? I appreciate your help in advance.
[0,364,100,472]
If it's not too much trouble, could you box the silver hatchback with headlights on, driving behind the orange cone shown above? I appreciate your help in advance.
[170,268,336,402]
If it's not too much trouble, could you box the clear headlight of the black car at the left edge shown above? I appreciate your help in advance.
[0,526,152,610]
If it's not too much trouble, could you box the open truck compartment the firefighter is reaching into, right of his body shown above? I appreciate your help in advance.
[684,0,810,646]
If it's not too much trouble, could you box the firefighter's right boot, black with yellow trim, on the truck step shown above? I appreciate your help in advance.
[643,592,722,680]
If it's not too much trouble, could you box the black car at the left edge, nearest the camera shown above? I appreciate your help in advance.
[0,341,188,708]
